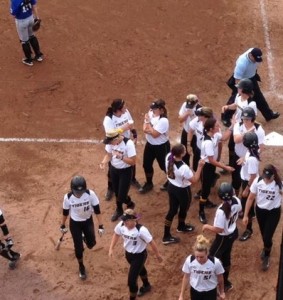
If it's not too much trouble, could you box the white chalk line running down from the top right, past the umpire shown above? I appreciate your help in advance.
[259,0,283,100]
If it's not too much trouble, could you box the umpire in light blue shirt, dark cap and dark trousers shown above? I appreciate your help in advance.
[222,48,280,125]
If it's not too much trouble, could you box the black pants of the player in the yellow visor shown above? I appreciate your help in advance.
[110,165,133,205]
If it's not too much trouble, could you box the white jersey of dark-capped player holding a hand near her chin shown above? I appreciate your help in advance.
[145,113,169,145]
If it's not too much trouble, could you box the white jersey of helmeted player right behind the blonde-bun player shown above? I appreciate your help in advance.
[213,196,242,236]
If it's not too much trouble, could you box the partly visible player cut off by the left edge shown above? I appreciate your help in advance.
[0,209,21,270]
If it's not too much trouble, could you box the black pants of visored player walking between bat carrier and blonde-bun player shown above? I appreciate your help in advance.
[126,250,147,297]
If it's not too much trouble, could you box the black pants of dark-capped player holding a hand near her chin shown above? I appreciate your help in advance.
[143,141,170,177]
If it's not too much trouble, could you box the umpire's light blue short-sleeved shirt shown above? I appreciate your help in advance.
[234,48,258,79]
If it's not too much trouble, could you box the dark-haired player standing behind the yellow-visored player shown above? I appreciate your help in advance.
[103,99,141,200]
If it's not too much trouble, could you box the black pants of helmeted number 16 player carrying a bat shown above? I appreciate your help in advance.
[70,216,96,260]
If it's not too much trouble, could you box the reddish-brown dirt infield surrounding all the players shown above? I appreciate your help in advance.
[0,0,283,300]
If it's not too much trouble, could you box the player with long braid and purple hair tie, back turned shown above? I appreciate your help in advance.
[162,144,204,245]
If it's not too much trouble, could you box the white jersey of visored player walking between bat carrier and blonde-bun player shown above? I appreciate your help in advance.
[114,221,152,253]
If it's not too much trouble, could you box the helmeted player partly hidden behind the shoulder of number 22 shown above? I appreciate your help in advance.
[238,132,260,242]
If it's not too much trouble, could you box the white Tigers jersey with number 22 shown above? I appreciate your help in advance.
[250,177,282,210]
